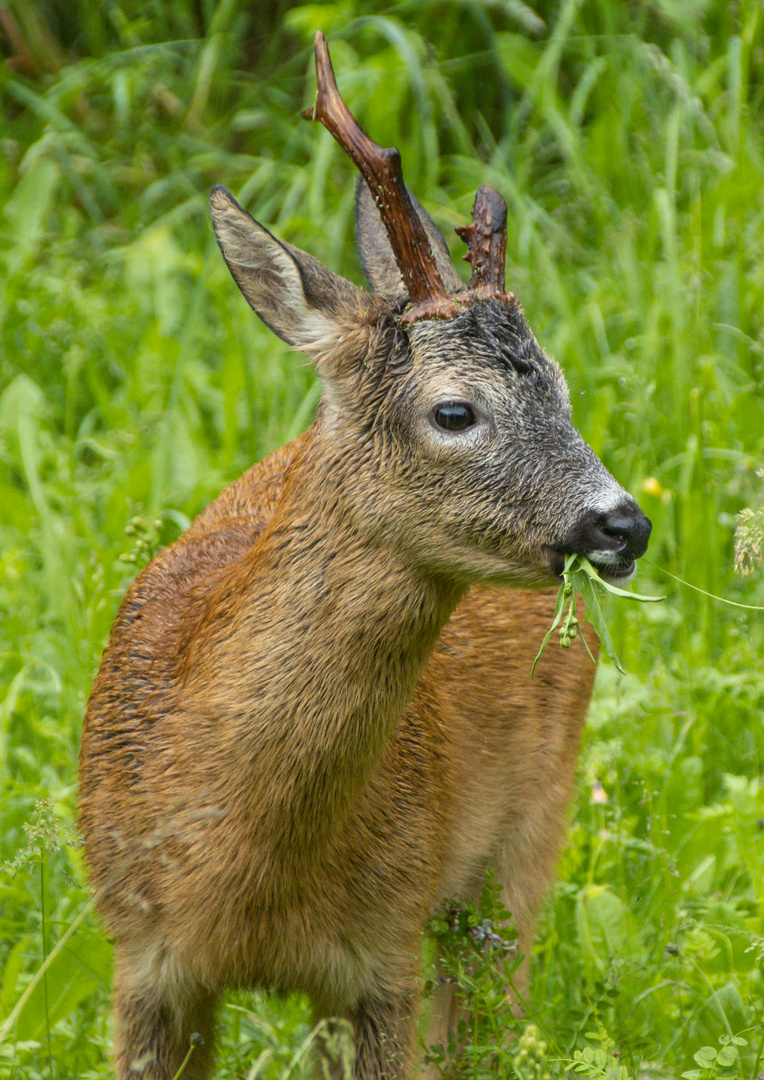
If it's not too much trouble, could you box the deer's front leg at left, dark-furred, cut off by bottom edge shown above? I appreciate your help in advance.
[113,953,216,1080]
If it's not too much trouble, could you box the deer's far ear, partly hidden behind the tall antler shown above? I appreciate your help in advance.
[356,176,465,296]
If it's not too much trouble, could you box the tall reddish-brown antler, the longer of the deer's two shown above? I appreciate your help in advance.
[303,30,456,322]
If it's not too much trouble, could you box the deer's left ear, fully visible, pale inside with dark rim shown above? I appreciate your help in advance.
[210,185,367,352]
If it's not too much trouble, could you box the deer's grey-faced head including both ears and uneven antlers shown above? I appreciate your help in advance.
[211,33,651,584]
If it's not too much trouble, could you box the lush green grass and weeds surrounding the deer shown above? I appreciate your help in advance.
[0,0,764,1080]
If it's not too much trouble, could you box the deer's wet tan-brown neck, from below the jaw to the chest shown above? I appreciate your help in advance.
[188,434,465,858]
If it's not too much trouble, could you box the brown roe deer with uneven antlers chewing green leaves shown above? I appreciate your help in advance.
[80,32,651,1080]
